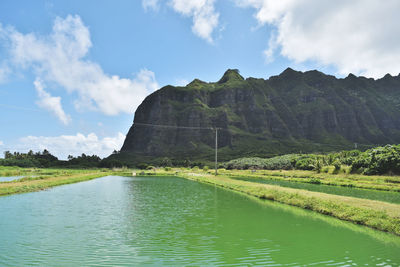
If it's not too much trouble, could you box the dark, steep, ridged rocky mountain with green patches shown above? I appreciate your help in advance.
[121,68,400,160]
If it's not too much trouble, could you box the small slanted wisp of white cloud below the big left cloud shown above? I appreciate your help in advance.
[34,79,71,125]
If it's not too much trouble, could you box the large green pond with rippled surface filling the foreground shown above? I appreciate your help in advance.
[0,176,400,266]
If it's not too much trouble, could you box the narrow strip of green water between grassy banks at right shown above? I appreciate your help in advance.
[231,176,400,204]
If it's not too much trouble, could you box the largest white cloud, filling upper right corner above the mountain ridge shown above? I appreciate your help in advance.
[236,0,400,78]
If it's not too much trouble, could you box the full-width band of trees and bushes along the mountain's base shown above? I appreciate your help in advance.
[0,145,400,175]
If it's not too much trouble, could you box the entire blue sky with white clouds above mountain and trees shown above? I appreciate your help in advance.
[0,0,400,159]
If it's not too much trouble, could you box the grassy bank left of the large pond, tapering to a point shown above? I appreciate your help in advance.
[0,167,115,196]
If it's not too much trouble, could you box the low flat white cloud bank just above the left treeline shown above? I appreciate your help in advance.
[16,133,125,159]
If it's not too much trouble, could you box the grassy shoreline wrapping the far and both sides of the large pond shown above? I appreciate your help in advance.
[0,169,400,236]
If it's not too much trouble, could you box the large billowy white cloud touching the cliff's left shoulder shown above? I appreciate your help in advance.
[3,15,159,118]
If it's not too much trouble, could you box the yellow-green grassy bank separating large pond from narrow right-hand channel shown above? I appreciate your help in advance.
[178,172,400,235]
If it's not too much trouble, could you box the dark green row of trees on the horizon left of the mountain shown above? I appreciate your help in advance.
[0,149,101,168]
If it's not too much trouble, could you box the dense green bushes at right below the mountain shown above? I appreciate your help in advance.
[224,145,400,175]
